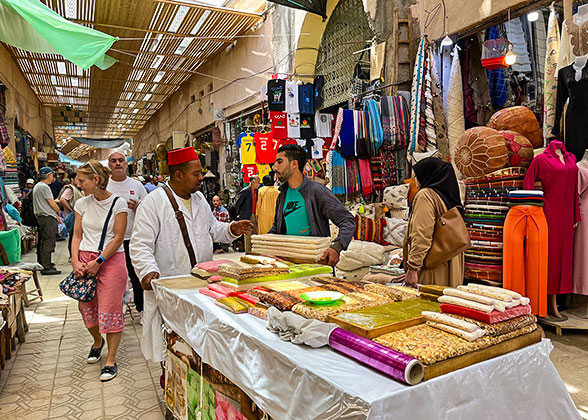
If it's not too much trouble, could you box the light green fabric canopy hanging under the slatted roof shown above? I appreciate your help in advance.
[0,0,117,70]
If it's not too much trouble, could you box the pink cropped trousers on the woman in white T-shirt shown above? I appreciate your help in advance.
[78,251,128,334]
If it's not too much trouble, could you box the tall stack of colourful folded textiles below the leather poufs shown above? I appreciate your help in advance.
[465,171,523,286]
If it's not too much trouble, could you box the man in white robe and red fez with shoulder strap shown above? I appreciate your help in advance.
[129,147,253,362]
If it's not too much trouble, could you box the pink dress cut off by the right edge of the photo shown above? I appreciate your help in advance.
[574,162,588,295]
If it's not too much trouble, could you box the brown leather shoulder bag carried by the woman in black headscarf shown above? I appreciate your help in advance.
[424,191,471,269]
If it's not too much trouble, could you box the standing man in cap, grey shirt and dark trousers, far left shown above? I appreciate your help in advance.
[33,166,61,276]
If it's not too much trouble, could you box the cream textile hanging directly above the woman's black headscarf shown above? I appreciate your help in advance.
[446,46,465,172]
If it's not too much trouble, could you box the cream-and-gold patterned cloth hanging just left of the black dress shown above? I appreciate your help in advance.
[543,4,560,144]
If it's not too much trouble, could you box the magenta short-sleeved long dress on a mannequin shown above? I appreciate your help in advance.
[523,140,580,295]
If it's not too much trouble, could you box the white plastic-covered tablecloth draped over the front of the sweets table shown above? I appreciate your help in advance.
[153,280,580,420]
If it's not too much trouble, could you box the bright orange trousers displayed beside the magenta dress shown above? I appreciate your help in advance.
[503,206,548,316]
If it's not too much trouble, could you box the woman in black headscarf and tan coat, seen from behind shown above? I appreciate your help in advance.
[404,157,464,287]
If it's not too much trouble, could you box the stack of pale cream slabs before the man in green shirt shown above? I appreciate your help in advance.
[251,234,331,262]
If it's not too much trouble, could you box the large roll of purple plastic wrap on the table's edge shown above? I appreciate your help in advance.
[329,328,425,385]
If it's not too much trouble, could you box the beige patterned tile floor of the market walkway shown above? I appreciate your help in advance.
[0,242,164,420]
